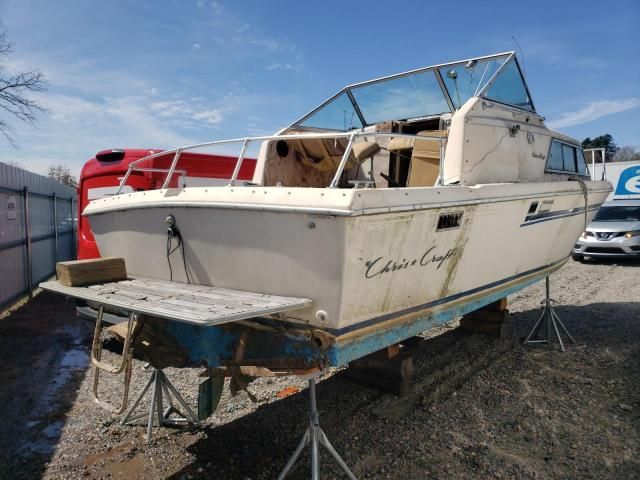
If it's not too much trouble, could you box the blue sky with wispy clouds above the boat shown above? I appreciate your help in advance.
[0,0,640,174]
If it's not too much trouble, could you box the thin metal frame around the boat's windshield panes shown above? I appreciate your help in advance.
[284,51,539,131]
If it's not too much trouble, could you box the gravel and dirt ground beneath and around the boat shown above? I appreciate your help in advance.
[0,261,640,480]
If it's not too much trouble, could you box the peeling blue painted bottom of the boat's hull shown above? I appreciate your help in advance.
[164,257,568,370]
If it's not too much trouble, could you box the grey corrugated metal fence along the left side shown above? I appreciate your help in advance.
[0,162,78,307]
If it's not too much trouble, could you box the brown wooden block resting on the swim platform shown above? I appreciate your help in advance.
[56,257,127,287]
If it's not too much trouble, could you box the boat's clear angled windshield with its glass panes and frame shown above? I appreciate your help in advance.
[291,52,535,131]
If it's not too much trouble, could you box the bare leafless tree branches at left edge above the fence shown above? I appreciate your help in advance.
[0,24,47,147]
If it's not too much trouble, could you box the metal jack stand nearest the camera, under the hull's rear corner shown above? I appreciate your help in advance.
[278,377,356,480]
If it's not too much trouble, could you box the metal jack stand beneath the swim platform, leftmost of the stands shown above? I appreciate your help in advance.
[120,365,200,443]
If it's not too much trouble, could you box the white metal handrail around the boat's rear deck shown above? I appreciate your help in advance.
[115,131,446,195]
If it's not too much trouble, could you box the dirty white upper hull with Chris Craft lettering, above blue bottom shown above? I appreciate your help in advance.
[85,182,609,335]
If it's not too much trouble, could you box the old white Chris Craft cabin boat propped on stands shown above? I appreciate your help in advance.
[52,52,611,371]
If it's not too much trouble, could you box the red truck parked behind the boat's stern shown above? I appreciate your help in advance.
[78,148,256,260]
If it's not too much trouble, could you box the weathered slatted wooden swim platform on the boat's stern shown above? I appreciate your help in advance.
[40,278,311,325]
